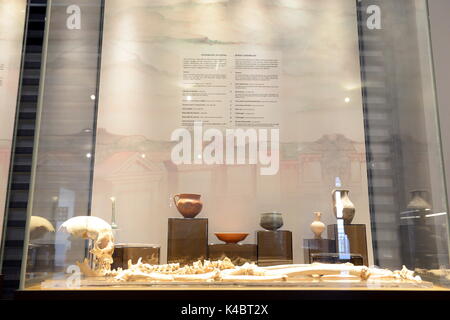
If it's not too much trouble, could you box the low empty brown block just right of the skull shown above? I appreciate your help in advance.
[112,243,160,269]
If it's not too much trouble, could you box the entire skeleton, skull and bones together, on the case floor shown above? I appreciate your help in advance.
[61,216,422,282]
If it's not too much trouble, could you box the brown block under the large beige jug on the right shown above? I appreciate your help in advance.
[327,224,369,266]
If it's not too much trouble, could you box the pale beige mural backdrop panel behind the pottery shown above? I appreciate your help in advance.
[92,0,372,262]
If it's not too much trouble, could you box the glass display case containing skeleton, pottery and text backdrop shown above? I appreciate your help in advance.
[12,0,450,290]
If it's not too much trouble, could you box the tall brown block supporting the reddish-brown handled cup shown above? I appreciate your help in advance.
[167,218,208,265]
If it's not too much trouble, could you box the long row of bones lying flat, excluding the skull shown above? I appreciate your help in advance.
[107,258,422,282]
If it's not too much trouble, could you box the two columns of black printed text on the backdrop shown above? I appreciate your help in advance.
[180,52,281,127]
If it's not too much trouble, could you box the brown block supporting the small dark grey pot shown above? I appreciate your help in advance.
[256,230,293,266]
